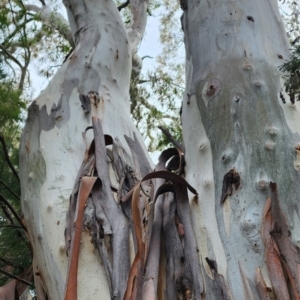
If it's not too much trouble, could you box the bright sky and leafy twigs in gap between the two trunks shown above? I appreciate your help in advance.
[130,0,185,152]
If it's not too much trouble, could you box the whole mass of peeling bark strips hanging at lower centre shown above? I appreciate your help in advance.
[65,117,203,300]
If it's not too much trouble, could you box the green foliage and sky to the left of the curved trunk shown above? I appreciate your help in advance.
[0,1,70,299]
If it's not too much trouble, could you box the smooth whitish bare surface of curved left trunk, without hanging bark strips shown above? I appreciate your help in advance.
[20,0,150,300]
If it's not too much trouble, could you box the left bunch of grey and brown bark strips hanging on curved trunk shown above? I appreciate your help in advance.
[65,118,136,299]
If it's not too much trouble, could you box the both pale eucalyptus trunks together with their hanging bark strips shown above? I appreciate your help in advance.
[20,0,300,300]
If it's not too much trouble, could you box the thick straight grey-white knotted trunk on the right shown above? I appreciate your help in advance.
[181,0,300,299]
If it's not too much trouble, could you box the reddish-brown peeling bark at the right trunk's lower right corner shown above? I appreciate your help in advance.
[256,182,300,300]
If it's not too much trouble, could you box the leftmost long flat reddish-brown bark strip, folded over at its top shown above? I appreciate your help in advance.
[65,177,97,300]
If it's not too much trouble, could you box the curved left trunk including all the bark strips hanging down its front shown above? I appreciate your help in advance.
[20,0,204,300]
